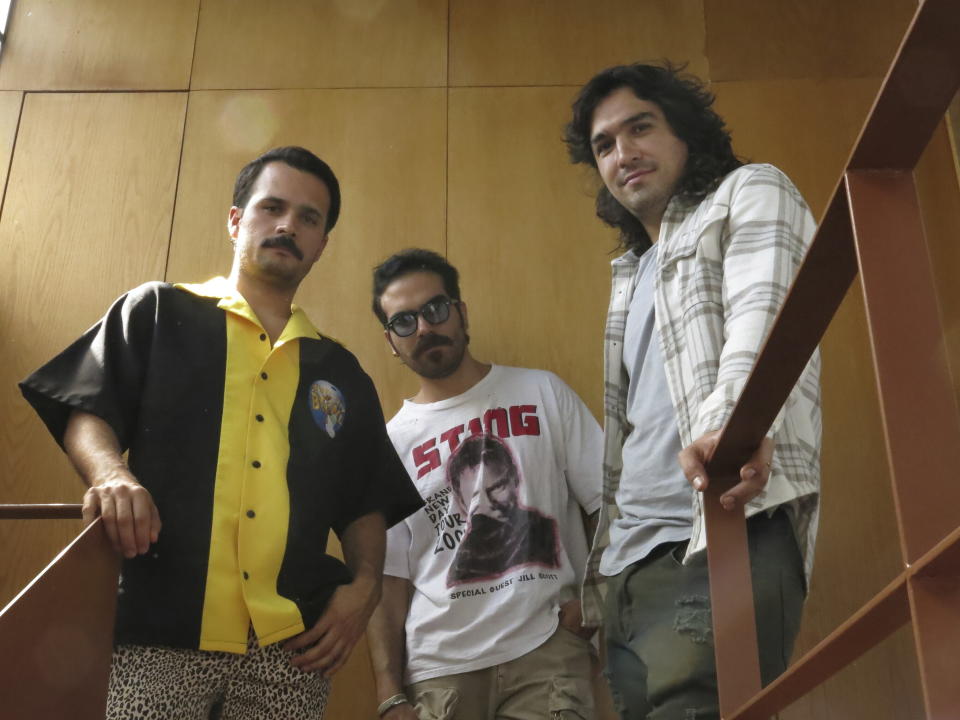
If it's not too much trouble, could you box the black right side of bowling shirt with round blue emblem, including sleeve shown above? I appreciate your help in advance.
[277,338,423,627]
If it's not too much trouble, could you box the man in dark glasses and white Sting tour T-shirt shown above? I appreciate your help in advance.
[367,250,601,720]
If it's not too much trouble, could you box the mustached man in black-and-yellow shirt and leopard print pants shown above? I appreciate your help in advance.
[21,147,423,720]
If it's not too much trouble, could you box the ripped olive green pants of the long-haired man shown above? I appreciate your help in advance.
[604,510,806,720]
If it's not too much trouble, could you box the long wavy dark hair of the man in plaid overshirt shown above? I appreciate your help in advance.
[564,62,743,250]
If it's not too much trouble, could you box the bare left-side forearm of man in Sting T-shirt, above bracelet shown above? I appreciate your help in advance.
[367,576,410,702]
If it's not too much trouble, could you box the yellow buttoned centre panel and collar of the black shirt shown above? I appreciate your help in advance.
[194,283,318,653]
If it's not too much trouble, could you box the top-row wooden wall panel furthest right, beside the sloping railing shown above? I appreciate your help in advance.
[704,0,917,82]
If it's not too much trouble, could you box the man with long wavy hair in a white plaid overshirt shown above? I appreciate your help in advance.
[566,64,820,720]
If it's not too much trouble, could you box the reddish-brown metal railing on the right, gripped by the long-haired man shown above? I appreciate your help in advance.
[705,0,960,720]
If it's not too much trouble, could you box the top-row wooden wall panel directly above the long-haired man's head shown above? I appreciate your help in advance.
[450,0,708,86]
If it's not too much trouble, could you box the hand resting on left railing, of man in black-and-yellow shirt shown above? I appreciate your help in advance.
[83,466,160,558]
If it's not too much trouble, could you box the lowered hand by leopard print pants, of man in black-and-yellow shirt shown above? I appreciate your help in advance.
[284,577,380,678]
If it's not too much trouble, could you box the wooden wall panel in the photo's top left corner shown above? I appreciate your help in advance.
[0,0,200,90]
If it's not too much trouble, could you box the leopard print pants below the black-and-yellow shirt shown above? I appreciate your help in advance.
[106,632,330,720]
